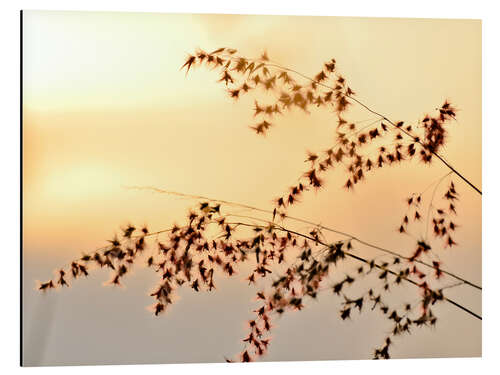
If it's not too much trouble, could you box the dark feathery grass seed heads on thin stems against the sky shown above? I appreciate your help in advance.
[39,48,482,362]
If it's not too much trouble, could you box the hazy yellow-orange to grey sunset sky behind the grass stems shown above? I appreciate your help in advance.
[23,11,482,366]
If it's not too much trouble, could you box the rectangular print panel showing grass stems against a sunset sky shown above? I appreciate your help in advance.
[21,11,482,366]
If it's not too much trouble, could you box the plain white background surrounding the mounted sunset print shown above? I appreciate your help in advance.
[0,0,500,374]
